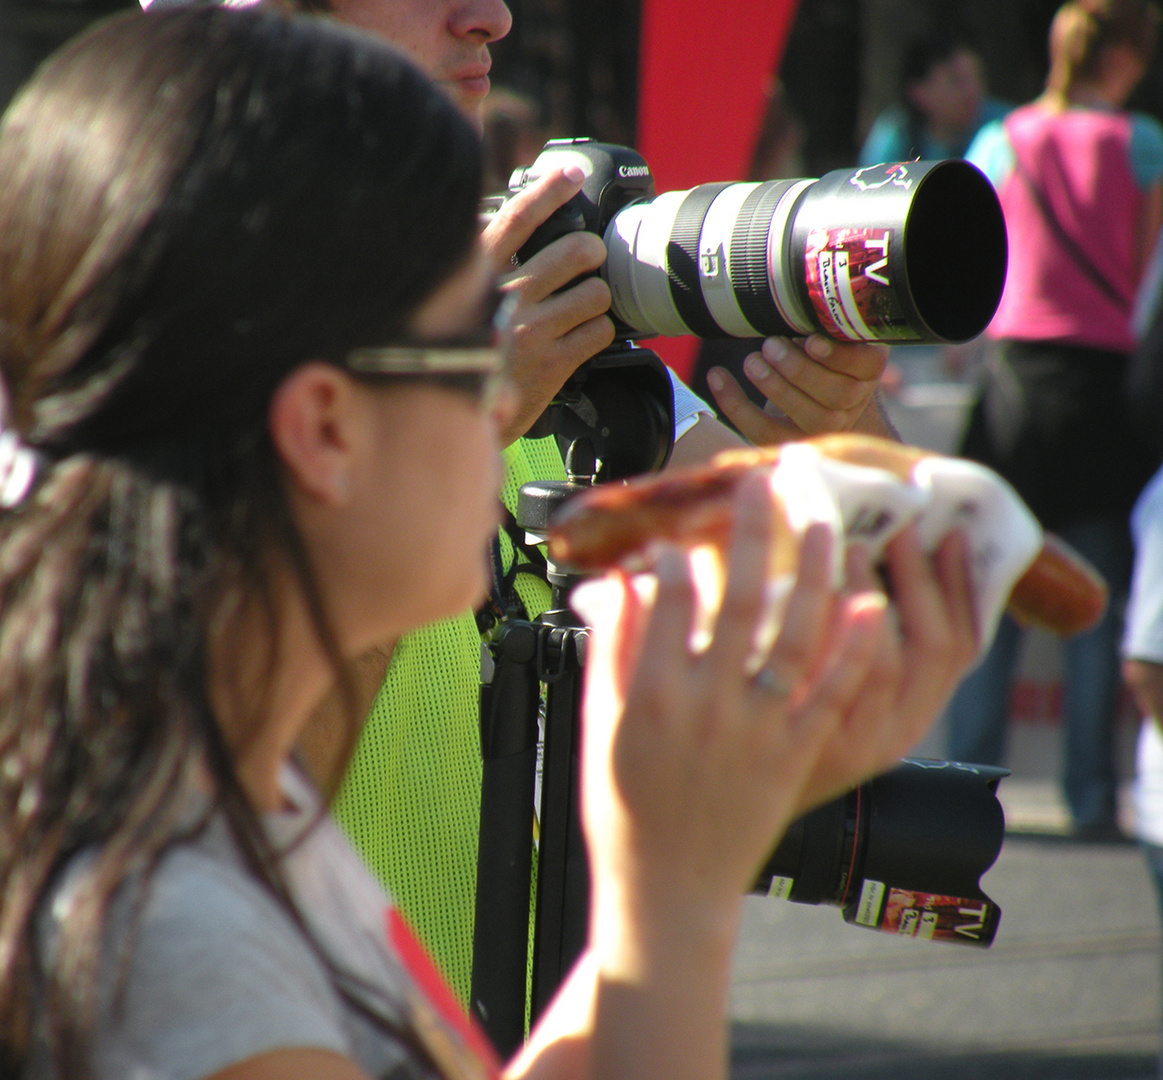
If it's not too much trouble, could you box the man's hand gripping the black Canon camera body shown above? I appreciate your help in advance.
[483,165,614,445]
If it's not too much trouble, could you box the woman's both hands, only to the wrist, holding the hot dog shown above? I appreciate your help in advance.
[578,477,976,925]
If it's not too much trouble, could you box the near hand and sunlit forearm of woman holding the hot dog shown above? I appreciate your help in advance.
[558,477,887,1080]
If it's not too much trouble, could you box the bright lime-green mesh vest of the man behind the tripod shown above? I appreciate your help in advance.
[333,438,565,1003]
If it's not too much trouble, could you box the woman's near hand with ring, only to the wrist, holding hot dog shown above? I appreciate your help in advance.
[577,477,891,917]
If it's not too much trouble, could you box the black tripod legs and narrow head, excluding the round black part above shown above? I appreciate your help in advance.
[471,443,595,1057]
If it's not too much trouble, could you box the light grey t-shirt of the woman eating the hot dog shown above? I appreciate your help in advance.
[31,771,483,1080]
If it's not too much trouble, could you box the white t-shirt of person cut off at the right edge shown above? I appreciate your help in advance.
[1122,469,1163,845]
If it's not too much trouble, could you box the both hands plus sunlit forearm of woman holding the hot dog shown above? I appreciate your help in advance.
[518,474,975,1080]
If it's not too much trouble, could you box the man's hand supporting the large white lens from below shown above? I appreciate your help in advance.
[707,334,897,445]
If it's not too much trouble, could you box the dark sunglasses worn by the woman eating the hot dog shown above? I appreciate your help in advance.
[343,288,518,409]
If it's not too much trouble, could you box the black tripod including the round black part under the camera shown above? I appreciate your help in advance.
[470,341,675,1056]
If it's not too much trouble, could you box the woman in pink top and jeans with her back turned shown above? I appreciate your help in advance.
[949,0,1163,839]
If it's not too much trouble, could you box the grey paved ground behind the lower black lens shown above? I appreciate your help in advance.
[732,358,1163,1080]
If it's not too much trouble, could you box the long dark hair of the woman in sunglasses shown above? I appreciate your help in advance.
[0,7,480,1077]
